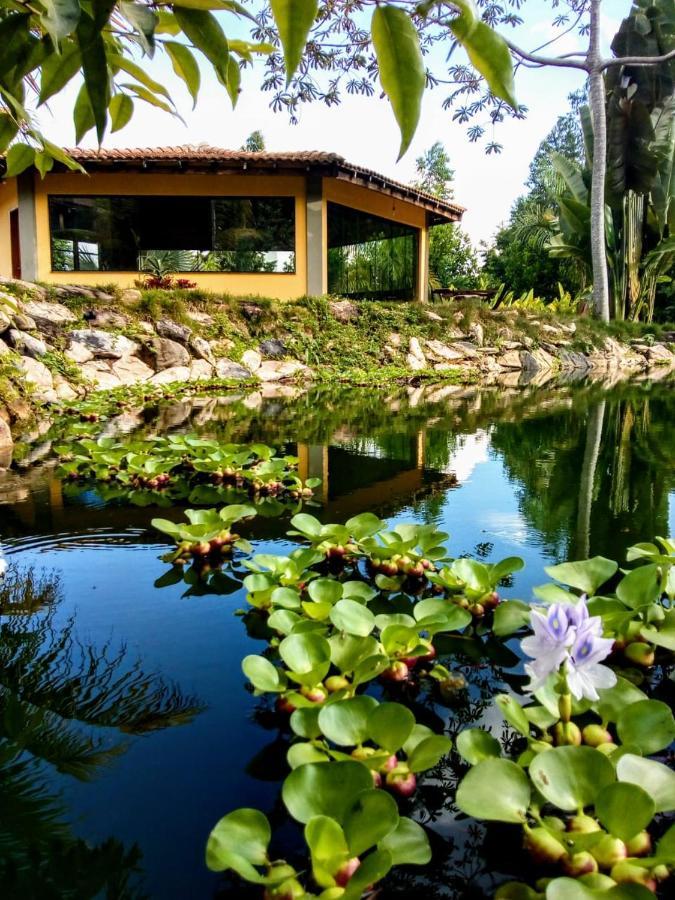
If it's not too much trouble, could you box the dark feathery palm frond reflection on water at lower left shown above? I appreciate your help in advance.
[0,567,202,900]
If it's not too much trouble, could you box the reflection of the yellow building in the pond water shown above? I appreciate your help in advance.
[297,431,456,519]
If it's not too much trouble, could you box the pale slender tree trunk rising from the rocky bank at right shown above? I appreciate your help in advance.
[587,0,609,322]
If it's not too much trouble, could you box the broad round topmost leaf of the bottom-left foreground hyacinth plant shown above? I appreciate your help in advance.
[281,761,373,823]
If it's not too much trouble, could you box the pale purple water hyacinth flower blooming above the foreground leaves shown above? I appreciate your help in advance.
[521,594,616,700]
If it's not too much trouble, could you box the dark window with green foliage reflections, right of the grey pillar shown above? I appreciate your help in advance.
[328,203,419,300]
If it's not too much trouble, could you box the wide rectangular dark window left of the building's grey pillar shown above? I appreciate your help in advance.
[49,197,295,273]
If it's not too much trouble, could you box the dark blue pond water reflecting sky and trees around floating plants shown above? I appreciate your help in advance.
[0,383,675,900]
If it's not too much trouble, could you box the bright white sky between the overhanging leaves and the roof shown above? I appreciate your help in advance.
[40,0,631,246]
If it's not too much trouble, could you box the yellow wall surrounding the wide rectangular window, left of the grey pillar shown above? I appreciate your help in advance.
[35,172,307,300]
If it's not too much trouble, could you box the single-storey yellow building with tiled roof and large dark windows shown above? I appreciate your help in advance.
[0,146,463,300]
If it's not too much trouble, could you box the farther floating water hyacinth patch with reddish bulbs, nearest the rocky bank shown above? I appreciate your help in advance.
[54,434,319,508]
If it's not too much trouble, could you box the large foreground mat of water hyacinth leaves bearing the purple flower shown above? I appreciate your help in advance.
[154,507,675,900]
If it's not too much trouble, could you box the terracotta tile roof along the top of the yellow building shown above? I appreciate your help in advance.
[58,144,464,220]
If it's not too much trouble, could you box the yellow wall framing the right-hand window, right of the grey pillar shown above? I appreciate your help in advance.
[323,178,429,302]
